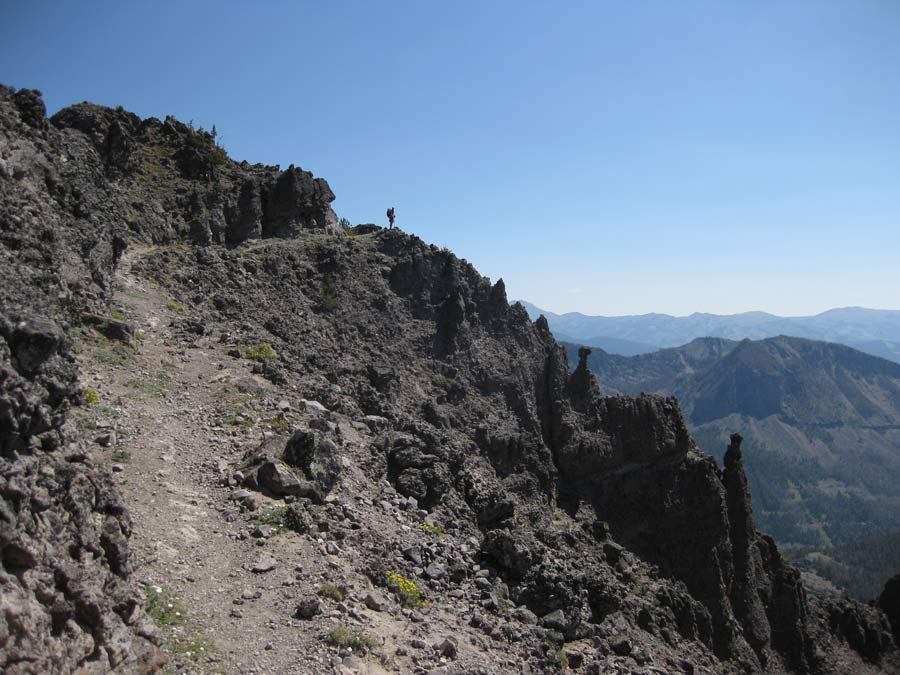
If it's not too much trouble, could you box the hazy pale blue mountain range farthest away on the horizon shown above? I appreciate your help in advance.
[521,301,900,363]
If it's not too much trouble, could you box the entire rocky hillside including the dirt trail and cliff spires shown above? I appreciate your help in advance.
[0,88,900,674]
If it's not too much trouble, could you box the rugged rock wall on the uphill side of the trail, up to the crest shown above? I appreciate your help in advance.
[0,86,336,673]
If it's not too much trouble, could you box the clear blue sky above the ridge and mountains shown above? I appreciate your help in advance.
[0,0,900,315]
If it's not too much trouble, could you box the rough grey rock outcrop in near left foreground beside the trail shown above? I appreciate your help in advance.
[0,316,160,674]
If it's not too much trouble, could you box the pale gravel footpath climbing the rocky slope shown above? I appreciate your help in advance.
[74,249,356,674]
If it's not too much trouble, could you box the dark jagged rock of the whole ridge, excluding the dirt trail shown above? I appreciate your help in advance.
[0,88,897,673]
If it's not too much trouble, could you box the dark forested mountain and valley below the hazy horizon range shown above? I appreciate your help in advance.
[567,336,900,600]
